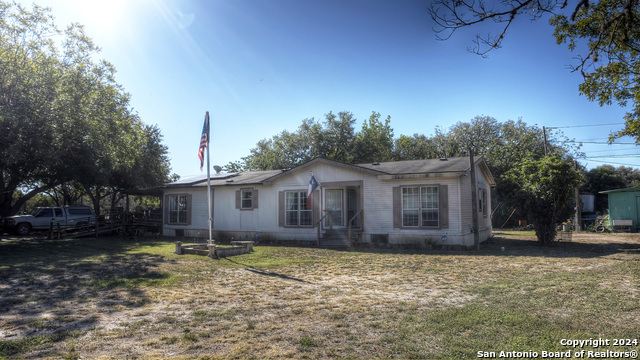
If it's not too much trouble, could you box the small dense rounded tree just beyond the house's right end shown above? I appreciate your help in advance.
[503,153,582,246]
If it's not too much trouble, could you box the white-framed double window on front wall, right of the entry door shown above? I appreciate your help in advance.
[402,186,440,227]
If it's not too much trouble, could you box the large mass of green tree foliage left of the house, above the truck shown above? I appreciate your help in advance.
[0,1,169,215]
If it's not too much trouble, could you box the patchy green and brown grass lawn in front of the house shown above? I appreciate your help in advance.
[0,232,640,359]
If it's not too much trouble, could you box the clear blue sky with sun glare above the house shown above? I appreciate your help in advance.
[15,0,640,178]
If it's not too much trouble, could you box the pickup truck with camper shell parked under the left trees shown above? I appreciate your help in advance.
[3,206,96,236]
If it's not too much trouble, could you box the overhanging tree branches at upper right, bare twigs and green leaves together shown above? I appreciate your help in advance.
[429,0,640,144]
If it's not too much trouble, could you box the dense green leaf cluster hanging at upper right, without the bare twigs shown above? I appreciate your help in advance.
[550,0,640,142]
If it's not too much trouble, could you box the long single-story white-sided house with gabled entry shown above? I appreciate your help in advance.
[163,157,495,246]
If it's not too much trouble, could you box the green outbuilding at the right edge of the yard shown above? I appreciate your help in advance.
[600,187,640,232]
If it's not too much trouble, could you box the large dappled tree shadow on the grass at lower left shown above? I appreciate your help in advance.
[0,237,176,338]
